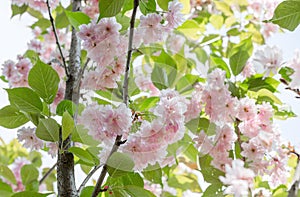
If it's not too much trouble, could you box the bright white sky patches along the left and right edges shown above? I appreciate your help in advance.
[0,0,300,172]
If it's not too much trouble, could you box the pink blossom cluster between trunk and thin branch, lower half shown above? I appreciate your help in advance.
[78,103,132,145]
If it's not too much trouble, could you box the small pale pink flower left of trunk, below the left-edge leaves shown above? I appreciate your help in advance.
[17,127,44,150]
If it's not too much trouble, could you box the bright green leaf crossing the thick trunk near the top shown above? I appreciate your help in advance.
[65,10,91,31]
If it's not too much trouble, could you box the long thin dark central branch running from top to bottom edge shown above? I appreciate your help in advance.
[92,0,139,197]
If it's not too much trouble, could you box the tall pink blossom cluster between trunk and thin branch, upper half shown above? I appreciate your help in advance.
[78,18,128,90]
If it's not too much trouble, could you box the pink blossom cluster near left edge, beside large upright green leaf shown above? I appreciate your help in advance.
[2,56,32,87]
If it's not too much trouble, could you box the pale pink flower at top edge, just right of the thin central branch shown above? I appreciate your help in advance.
[166,0,184,29]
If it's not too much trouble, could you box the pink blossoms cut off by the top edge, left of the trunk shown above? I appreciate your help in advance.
[12,0,59,13]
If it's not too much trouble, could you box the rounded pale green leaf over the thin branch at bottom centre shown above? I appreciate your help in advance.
[107,152,134,177]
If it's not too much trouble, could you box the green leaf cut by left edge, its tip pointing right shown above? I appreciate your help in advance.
[0,105,29,129]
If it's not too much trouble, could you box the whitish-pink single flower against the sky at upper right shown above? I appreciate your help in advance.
[253,46,282,77]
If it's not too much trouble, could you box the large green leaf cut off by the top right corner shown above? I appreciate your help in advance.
[269,0,300,31]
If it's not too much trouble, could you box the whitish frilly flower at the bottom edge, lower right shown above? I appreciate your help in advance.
[219,159,255,197]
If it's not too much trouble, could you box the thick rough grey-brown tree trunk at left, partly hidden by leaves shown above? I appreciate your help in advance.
[57,0,81,197]
